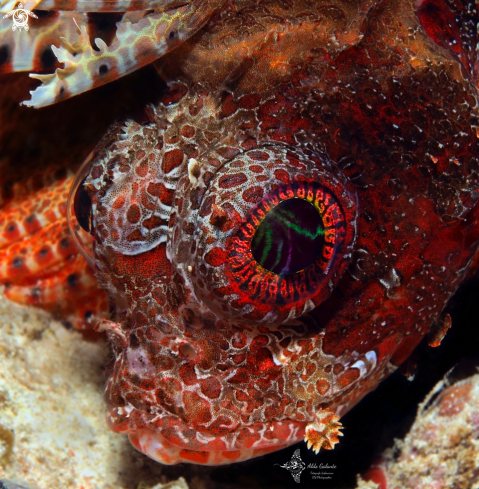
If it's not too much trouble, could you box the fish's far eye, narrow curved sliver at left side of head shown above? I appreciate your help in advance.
[67,154,95,268]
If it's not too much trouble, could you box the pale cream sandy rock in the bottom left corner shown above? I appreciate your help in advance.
[0,296,188,489]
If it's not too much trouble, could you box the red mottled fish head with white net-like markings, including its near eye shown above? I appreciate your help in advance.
[67,0,479,465]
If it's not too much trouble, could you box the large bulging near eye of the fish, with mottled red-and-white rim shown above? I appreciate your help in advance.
[189,149,357,324]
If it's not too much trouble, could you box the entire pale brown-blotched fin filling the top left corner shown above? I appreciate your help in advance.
[0,0,224,108]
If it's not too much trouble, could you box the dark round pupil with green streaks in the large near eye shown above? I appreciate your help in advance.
[251,198,324,275]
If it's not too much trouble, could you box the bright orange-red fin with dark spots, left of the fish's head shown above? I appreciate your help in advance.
[0,167,108,329]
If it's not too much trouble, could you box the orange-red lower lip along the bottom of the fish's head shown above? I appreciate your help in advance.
[128,420,306,465]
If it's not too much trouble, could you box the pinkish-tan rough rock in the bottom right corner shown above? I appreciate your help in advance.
[358,368,479,489]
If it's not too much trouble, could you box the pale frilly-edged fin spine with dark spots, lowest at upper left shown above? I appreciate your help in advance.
[23,0,223,108]
